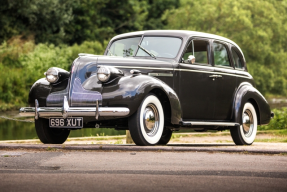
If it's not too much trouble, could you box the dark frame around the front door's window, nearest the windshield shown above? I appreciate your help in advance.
[179,36,213,67]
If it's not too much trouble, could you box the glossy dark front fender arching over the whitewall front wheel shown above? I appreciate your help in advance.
[102,75,182,125]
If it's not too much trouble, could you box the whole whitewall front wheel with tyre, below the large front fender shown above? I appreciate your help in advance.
[129,94,164,145]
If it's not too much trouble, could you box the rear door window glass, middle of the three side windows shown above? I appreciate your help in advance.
[213,42,231,67]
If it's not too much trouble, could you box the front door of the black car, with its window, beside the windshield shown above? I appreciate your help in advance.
[178,39,215,121]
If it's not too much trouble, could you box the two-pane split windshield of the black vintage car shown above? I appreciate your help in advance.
[107,37,182,58]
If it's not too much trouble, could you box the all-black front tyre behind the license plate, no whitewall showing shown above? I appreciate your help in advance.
[35,118,70,144]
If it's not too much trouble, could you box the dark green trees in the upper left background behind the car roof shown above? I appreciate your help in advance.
[0,0,179,45]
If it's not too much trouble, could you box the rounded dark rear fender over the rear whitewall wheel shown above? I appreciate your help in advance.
[233,83,271,125]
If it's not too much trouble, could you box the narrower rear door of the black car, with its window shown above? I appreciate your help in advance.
[212,41,236,121]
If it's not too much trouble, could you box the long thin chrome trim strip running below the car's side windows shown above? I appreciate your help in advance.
[109,66,251,79]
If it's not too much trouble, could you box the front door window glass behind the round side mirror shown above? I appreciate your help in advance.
[183,40,209,64]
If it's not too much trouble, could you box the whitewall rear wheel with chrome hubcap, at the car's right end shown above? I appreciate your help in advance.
[230,102,257,145]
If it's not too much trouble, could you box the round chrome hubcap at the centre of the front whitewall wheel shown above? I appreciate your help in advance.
[143,104,159,136]
